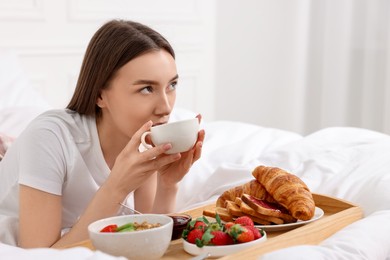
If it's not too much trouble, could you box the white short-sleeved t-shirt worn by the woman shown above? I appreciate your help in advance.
[0,110,120,244]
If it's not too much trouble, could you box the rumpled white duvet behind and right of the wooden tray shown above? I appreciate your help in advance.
[174,114,390,260]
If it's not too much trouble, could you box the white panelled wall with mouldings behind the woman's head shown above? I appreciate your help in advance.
[0,0,215,119]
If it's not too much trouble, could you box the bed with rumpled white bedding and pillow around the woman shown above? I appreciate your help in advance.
[0,49,390,259]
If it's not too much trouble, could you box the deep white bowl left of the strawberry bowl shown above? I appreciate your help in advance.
[88,214,173,259]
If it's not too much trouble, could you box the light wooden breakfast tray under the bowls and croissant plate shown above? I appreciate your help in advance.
[64,193,363,259]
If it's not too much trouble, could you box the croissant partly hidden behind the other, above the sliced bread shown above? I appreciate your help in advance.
[216,180,276,208]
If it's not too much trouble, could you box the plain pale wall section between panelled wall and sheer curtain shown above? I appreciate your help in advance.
[216,0,308,132]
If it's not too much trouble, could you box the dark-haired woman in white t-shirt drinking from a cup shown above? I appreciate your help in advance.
[0,20,205,248]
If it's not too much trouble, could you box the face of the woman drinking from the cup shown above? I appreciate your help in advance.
[97,50,178,138]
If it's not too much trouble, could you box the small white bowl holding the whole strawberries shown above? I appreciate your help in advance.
[183,232,267,257]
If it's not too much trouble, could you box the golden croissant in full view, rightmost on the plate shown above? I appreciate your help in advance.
[252,166,315,220]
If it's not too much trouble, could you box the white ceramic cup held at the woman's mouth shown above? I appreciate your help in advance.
[141,118,199,154]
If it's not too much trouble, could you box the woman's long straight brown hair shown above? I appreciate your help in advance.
[67,20,175,117]
